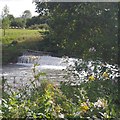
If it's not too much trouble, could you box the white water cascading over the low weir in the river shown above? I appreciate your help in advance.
[17,55,66,70]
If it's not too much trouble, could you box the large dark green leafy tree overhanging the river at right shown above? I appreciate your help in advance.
[36,2,118,62]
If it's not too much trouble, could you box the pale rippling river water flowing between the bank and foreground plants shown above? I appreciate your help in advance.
[2,54,73,87]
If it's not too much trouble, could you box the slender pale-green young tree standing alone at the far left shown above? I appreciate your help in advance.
[2,5,10,36]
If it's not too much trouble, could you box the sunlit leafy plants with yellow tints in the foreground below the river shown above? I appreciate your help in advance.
[2,62,120,120]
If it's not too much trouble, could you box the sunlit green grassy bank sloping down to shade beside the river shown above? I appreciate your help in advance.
[0,29,42,64]
